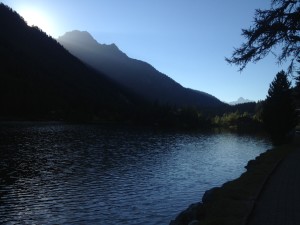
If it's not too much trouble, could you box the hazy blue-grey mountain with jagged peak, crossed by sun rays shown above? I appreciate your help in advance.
[57,30,224,108]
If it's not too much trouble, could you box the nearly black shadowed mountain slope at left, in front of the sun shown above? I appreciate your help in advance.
[0,3,136,121]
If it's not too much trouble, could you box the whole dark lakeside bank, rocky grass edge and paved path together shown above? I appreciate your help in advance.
[170,134,300,225]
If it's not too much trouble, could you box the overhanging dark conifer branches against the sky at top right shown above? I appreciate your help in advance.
[226,0,300,72]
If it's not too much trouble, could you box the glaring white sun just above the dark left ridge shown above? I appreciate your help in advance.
[19,7,55,36]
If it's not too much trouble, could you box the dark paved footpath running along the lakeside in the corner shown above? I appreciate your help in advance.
[247,135,300,225]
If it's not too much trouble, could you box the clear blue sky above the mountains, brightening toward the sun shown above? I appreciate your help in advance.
[1,0,287,102]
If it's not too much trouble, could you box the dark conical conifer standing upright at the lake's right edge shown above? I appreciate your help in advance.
[262,71,297,144]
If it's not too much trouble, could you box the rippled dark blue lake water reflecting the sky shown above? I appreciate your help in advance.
[0,123,271,225]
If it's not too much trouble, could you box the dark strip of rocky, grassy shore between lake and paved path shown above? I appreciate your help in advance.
[169,135,300,225]
